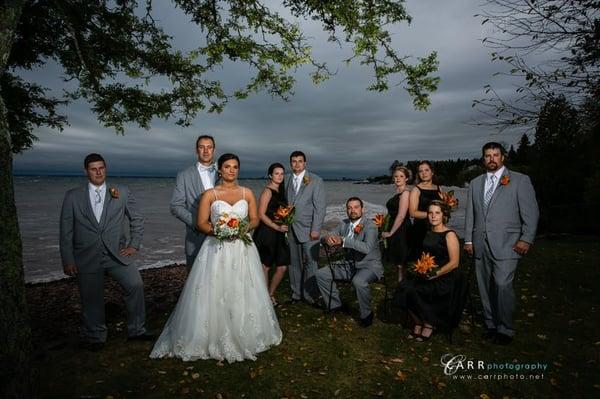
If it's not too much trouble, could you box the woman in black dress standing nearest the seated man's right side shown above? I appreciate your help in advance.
[381,166,412,281]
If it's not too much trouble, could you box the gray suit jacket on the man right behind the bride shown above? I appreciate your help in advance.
[170,164,212,257]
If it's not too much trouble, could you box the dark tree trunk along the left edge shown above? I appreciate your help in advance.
[0,0,37,398]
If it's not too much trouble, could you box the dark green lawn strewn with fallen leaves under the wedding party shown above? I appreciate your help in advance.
[32,237,600,398]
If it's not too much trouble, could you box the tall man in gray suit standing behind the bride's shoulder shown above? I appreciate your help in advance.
[171,135,217,274]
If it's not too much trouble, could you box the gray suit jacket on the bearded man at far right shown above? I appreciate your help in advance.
[465,168,539,260]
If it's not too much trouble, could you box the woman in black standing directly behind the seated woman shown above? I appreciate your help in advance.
[408,161,440,260]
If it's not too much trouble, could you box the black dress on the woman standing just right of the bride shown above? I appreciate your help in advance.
[252,187,290,267]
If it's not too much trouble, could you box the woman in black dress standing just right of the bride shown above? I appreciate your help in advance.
[253,163,290,306]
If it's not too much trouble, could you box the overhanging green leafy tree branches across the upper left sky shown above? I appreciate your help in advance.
[3,0,439,139]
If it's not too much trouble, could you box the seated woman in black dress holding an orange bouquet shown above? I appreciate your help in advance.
[404,200,464,341]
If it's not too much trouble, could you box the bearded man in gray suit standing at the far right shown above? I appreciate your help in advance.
[465,142,539,345]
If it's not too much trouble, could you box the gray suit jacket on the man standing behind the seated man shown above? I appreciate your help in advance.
[285,171,326,242]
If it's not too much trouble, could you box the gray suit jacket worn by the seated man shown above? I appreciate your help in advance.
[334,216,383,278]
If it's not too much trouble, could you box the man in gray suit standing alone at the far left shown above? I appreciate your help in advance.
[60,154,155,350]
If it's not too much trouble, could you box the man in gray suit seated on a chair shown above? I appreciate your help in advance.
[317,197,383,327]
